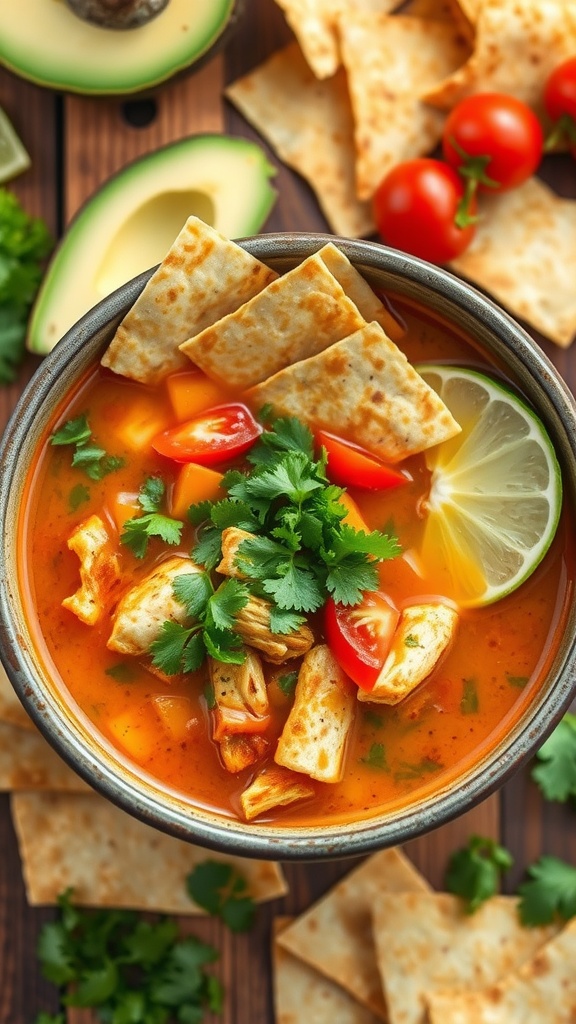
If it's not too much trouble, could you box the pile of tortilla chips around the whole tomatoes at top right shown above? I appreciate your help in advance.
[227,0,576,346]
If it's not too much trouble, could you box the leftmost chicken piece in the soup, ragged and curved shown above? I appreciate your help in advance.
[61,515,120,626]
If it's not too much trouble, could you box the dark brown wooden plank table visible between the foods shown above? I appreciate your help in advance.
[0,0,576,1024]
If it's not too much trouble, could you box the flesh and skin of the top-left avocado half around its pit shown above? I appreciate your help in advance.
[0,0,242,95]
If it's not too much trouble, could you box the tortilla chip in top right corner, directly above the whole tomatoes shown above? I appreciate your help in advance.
[423,0,576,112]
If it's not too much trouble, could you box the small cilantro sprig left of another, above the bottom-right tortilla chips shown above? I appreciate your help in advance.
[444,836,513,913]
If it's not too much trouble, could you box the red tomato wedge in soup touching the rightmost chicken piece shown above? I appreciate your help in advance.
[324,591,399,690]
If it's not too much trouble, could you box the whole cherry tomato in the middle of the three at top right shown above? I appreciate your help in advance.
[442,92,544,191]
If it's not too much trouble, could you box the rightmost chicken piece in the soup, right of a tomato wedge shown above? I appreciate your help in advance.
[358,602,458,705]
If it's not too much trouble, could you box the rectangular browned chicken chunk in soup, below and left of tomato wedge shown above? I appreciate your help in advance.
[274,644,357,782]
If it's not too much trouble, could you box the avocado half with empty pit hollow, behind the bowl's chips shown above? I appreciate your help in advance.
[27,134,276,355]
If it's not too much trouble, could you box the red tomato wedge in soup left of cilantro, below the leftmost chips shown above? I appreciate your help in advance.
[152,403,262,466]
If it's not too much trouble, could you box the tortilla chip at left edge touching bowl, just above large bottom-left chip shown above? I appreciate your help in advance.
[0,722,90,793]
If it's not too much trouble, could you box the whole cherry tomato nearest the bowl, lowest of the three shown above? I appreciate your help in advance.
[373,157,476,263]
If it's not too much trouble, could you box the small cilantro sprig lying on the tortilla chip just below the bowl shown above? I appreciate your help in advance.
[186,860,255,932]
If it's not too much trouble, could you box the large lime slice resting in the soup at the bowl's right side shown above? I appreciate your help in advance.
[418,366,562,607]
